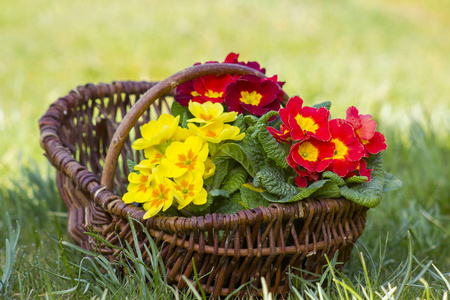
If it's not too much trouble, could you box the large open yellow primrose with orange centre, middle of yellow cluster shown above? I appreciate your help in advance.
[161,136,209,178]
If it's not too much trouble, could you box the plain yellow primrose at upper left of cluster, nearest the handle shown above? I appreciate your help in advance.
[133,114,180,150]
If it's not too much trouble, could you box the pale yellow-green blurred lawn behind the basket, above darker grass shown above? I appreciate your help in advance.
[0,0,450,177]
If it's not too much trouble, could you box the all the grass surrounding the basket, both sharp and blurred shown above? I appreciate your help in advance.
[0,0,450,299]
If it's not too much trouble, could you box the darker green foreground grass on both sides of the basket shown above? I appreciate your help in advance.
[0,126,450,299]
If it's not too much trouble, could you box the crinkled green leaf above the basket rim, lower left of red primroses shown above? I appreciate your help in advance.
[253,168,297,198]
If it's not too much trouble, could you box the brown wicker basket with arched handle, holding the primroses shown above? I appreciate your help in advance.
[39,64,367,297]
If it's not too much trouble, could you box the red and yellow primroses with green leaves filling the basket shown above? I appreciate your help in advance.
[123,53,401,218]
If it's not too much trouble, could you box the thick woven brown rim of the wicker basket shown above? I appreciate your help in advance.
[39,81,366,231]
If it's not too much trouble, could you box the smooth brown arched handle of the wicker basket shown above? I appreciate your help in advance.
[102,63,288,191]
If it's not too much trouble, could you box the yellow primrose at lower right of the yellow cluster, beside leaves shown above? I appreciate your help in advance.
[173,172,208,209]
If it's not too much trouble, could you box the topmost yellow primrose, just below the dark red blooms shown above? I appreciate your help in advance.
[188,101,237,124]
